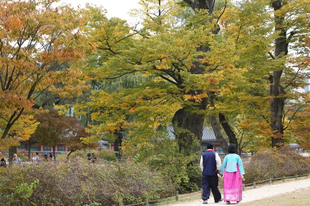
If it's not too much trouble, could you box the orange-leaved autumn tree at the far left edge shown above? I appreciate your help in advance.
[0,0,86,153]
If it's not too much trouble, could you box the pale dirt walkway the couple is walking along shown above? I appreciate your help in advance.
[169,178,310,206]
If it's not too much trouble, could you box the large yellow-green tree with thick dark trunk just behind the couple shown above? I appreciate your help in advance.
[76,1,239,192]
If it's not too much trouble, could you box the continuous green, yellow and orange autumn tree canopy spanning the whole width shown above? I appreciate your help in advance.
[0,0,310,159]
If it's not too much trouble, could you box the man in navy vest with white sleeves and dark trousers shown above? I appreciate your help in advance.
[200,142,222,204]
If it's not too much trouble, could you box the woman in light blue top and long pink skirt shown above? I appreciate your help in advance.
[220,144,244,204]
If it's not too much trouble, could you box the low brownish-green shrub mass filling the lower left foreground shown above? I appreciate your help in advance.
[0,159,175,205]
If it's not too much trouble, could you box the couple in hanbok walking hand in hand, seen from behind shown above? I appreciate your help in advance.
[200,143,244,204]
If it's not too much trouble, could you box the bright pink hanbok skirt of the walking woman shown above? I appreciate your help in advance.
[223,165,242,202]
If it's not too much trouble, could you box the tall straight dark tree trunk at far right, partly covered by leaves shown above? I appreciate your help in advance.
[270,0,288,147]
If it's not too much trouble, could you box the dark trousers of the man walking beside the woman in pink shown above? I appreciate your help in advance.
[202,175,222,202]
